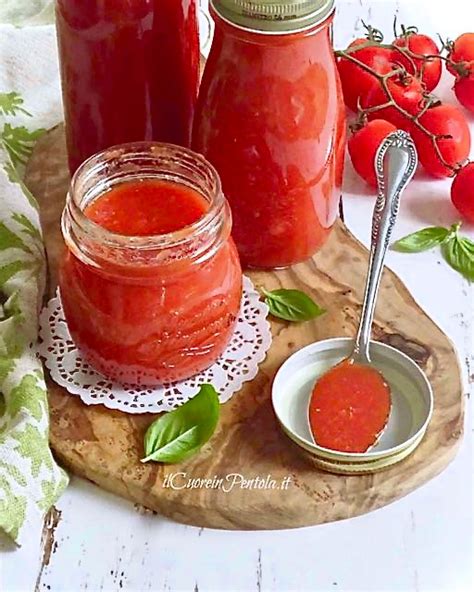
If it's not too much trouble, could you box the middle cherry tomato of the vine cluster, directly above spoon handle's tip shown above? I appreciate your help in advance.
[361,76,424,129]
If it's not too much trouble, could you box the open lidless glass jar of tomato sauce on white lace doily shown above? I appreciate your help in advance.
[59,143,242,385]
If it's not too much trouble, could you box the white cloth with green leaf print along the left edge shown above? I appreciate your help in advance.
[0,0,67,544]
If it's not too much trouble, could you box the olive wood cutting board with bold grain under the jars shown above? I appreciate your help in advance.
[27,126,463,529]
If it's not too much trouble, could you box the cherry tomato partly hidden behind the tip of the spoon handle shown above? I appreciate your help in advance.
[347,119,397,187]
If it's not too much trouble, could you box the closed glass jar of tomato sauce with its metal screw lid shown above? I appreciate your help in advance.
[193,0,345,268]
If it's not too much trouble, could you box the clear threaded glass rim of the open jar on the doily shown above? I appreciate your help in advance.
[62,141,226,251]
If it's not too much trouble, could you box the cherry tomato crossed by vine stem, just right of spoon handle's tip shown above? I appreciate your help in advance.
[412,105,471,177]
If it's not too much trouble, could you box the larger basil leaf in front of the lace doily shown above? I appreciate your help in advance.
[142,384,220,463]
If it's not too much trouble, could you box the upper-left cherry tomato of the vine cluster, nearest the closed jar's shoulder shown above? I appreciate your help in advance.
[337,38,392,111]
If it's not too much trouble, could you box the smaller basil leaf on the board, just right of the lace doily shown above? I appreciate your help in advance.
[262,288,326,322]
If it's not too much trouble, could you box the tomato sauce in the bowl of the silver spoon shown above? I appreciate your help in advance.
[309,360,391,452]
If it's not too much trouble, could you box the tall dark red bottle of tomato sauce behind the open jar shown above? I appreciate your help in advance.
[56,0,199,173]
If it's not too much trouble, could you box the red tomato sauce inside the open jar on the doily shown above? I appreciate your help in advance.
[60,164,241,385]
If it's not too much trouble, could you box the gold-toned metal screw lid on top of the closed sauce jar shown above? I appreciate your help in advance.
[210,0,335,34]
